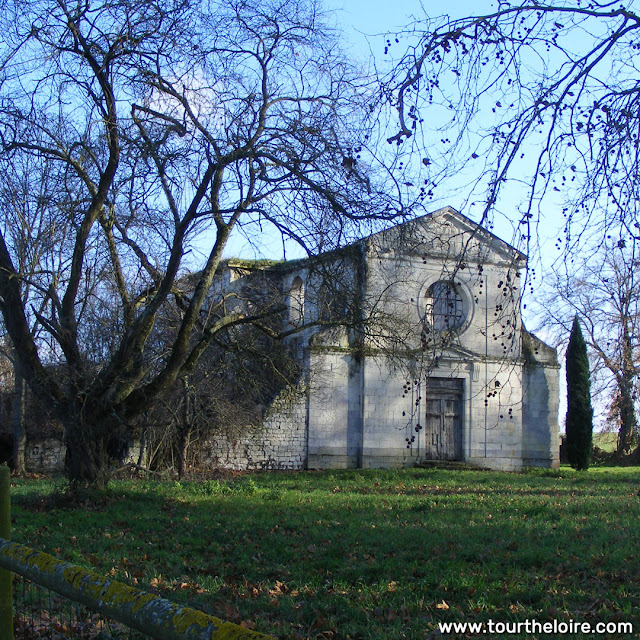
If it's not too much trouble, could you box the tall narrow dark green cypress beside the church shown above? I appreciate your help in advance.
[566,315,593,470]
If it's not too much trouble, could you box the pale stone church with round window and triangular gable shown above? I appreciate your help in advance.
[201,207,559,470]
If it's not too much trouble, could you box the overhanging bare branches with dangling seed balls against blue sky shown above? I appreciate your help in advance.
[386,0,640,249]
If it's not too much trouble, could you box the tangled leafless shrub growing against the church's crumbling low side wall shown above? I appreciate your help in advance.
[139,318,301,478]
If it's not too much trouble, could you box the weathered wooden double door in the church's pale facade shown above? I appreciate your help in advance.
[424,378,462,460]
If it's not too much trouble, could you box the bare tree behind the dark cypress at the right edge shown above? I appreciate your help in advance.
[542,239,640,454]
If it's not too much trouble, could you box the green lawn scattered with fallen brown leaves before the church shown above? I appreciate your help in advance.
[8,468,640,640]
